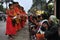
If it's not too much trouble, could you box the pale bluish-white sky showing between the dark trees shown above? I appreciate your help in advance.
[3,0,49,12]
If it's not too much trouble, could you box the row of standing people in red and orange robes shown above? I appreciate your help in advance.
[5,2,27,39]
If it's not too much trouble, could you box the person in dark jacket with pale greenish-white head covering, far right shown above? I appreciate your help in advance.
[44,15,60,40]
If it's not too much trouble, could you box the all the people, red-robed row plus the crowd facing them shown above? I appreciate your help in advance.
[5,2,60,40]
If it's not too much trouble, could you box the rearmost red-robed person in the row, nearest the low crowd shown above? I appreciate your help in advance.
[18,5,28,28]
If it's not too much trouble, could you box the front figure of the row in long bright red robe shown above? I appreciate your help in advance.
[6,4,16,39]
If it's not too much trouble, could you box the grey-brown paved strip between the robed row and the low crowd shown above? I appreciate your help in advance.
[15,23,29,40]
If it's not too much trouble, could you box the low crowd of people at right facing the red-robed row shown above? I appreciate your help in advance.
[28,14,60,40]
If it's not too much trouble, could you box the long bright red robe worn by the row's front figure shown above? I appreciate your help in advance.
[6,10,16,35]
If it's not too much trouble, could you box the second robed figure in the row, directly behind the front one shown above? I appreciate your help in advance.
[13,2,22,31]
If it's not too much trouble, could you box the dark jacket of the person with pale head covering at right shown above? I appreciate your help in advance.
[45,23,60,40]
